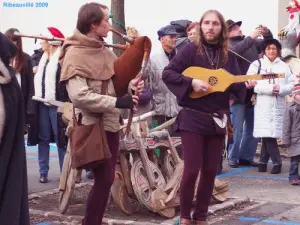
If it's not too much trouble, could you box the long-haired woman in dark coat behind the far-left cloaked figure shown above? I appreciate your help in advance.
[5,28,34,126]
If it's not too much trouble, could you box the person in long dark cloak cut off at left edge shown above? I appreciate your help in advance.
[0,32,30,225]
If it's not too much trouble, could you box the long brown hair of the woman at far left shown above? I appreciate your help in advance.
[5,28,25,73]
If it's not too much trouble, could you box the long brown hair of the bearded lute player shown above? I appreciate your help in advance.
[197,10,229,63]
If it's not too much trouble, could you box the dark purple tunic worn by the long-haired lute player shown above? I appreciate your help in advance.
[162,43,245,135]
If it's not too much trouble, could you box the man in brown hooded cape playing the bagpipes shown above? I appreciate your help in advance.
[60,2,144,225]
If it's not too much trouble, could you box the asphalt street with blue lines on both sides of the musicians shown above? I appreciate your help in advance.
[27,145,300,225]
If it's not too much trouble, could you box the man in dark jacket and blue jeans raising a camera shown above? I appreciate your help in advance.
[226,20,273,168]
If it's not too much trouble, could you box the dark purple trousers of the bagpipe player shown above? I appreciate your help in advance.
[84,132,119,225]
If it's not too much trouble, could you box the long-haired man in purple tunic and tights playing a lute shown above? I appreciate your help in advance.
[162,10,253,225]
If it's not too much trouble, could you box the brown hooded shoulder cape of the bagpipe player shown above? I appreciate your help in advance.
[59,29,117,81]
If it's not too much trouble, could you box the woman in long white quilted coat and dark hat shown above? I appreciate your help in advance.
[247,39,294,174]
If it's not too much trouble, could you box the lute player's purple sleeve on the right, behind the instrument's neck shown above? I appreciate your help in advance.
[228,54,247,102]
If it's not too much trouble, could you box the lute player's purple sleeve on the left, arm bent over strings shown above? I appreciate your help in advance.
[162,44,196,100]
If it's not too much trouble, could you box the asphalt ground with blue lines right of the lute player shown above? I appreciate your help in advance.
[211,159,300,225]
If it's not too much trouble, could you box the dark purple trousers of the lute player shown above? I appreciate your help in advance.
[180,131,225,221]
